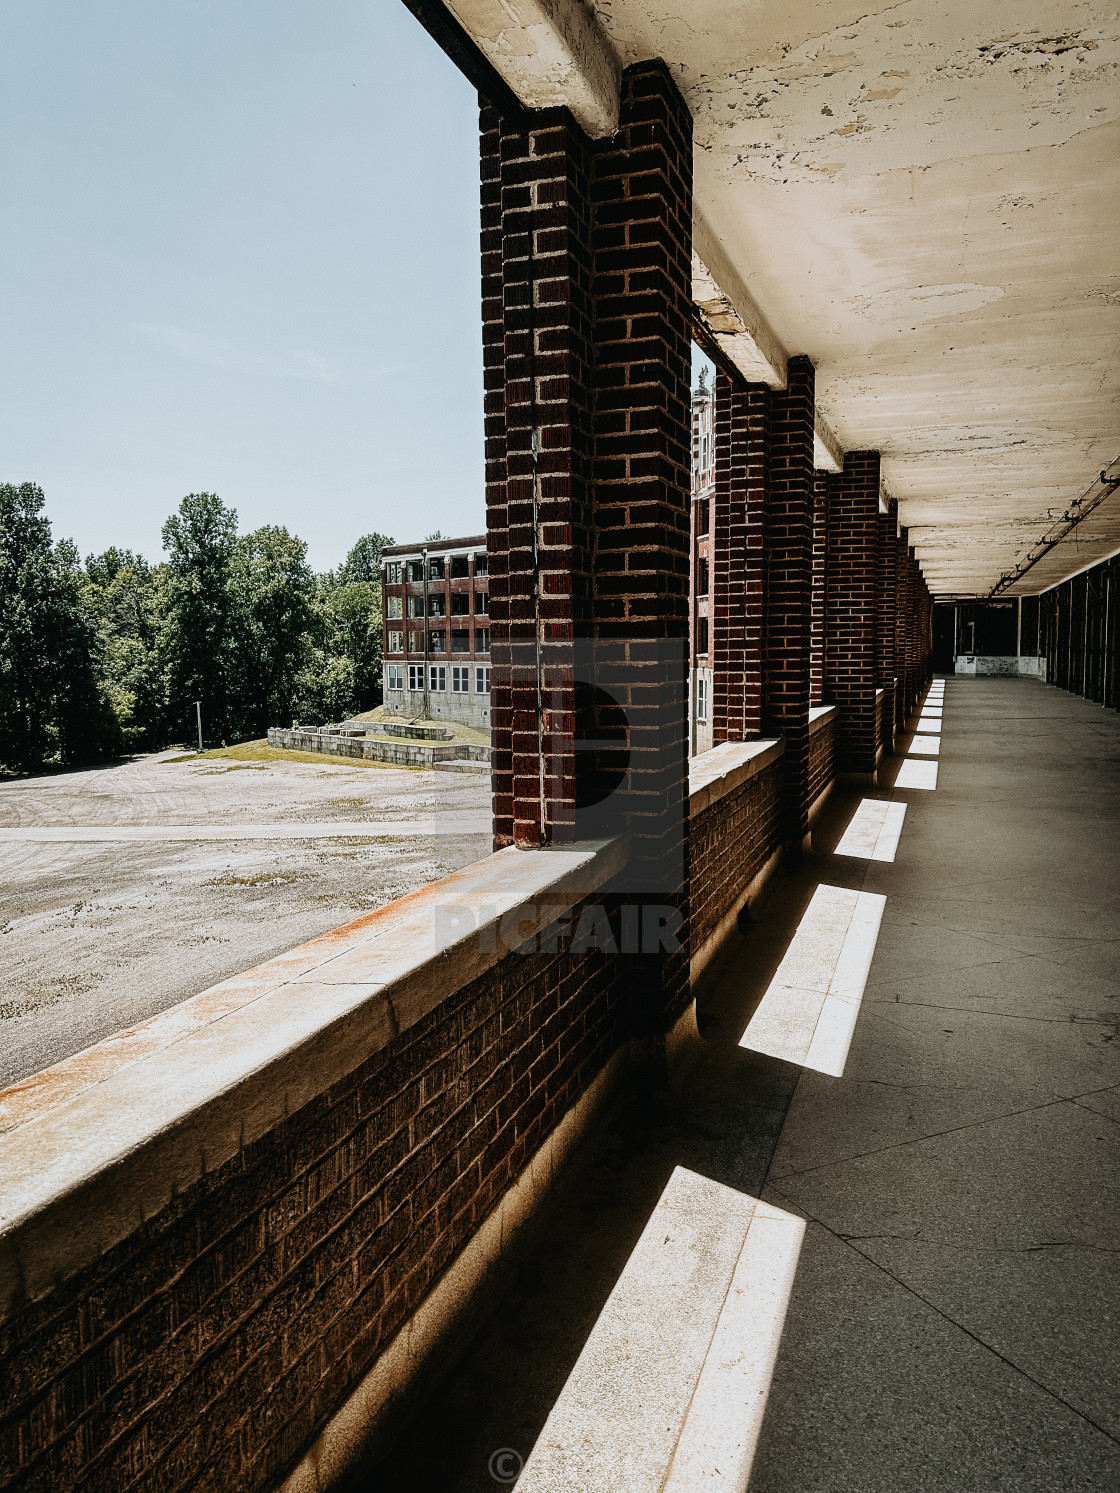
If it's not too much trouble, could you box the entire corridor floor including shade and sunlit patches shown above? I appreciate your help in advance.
[370,678,1120,1493]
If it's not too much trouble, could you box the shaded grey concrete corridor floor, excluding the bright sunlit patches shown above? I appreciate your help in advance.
[364,678,1120,1493]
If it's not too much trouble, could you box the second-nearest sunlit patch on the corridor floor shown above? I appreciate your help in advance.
[739,885,887,1078]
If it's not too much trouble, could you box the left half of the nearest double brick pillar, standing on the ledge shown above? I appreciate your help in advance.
[481,109,591,848]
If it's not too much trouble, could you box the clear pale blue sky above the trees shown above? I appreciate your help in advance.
[0,0,713,569]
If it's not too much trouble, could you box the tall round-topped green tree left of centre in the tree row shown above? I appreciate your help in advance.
[161,493,237,736]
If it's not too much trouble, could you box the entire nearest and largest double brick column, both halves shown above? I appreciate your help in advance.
[481,63,691,1026]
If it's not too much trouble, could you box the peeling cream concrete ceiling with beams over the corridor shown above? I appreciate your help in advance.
[447,0,1120,594]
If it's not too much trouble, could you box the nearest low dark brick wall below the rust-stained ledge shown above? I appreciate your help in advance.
[0,895,620,1493]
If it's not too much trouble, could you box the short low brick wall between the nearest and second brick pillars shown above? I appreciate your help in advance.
[690,757,783,950]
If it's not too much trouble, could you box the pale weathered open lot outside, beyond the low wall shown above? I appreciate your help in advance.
[0,752,490,1085]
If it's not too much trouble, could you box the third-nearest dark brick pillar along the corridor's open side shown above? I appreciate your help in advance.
[824,451,880,776]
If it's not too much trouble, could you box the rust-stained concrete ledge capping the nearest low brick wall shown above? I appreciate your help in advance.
[0,839,627,1312]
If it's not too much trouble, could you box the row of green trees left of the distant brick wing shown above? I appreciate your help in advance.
[0,482,393,770]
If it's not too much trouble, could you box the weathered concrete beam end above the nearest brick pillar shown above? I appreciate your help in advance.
[444,0,621,140]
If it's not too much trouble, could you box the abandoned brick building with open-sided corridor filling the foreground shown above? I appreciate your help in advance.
[0,0,1120,1493]
